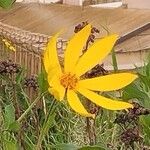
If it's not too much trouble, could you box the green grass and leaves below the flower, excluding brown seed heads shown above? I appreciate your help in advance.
[0,58,150,150]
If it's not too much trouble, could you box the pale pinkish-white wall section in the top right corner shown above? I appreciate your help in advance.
[123,0,150,9]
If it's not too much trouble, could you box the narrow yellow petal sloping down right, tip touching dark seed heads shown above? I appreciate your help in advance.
[77,88,133,110]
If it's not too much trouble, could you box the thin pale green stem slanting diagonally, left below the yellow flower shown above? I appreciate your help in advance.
[17,92,46,122]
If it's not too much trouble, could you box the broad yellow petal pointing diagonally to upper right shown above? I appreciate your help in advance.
[75,34,118,76]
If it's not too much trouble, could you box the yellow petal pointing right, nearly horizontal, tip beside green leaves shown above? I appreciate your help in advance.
[78,73,137,91]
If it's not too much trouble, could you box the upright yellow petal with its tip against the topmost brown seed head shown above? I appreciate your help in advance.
[64,25,91,72]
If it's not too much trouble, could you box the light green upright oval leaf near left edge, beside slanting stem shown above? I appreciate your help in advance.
[4,104,15,128]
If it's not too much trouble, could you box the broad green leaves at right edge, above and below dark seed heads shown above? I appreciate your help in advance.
[123,59,150,145]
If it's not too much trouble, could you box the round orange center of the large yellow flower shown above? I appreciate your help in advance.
[60,73,78,90]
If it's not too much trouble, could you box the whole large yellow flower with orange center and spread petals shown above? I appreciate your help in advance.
[44,25,137,118]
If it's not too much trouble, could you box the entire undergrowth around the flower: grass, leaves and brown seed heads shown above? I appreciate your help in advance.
[0,24,150,150]
